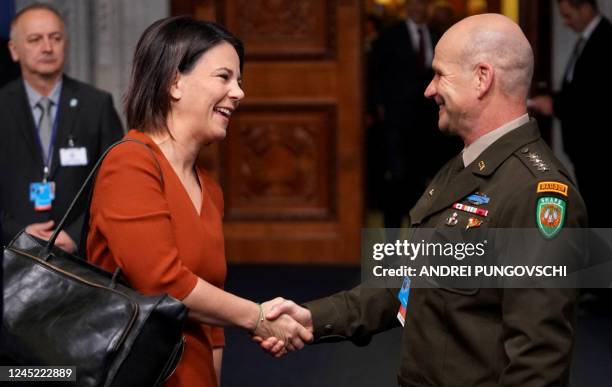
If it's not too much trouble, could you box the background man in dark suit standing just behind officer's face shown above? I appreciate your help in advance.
[370,0,456,228]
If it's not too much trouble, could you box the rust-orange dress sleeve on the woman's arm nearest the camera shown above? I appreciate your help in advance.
[92,143,198,299]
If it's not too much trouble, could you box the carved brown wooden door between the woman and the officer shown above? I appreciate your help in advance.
[172,0,363,263]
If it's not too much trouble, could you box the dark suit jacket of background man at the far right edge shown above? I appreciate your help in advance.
[554,18,612,227]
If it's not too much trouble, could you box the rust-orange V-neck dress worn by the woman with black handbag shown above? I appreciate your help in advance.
[87,130,227,387]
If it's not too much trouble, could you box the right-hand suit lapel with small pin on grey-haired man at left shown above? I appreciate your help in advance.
[50,76,79,177]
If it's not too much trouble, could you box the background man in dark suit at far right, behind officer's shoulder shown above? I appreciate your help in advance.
[531,0,612,228]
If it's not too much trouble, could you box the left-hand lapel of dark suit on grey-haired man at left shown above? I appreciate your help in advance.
[7,78,43,167]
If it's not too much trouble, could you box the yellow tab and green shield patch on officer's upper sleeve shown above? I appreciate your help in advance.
[536,181,569,239]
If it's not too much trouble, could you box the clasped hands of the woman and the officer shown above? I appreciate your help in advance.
[252,297,313,357]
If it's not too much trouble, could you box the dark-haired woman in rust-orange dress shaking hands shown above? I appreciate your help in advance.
[87,17,312,387]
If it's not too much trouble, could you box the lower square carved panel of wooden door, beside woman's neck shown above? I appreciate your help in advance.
[222,106,335,220]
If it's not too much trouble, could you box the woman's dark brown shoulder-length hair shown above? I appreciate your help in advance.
[124,16,244,133]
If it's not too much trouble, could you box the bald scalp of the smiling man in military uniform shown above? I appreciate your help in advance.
[436,14,533,99]
